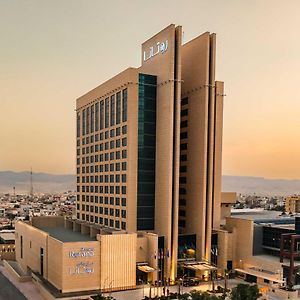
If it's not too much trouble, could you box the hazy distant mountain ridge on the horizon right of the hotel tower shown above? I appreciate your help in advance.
[222,175,300,196]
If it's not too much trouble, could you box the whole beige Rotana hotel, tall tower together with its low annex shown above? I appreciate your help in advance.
[12,24,246,293]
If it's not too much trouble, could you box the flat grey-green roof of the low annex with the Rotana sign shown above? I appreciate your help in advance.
[38,227,96,243]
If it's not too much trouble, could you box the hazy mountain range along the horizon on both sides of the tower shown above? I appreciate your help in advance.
[0,171,300,196]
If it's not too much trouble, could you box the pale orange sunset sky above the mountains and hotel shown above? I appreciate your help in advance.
[0,0,300,179]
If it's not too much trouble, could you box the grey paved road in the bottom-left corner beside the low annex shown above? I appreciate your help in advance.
[0,266,45,300]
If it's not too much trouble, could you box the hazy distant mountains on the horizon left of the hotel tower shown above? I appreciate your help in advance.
[0,171,76,194]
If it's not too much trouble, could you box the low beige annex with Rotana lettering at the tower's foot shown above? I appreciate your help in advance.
[16,217,158,294]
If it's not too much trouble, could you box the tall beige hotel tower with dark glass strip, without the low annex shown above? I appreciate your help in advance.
[76,25,223,279]
